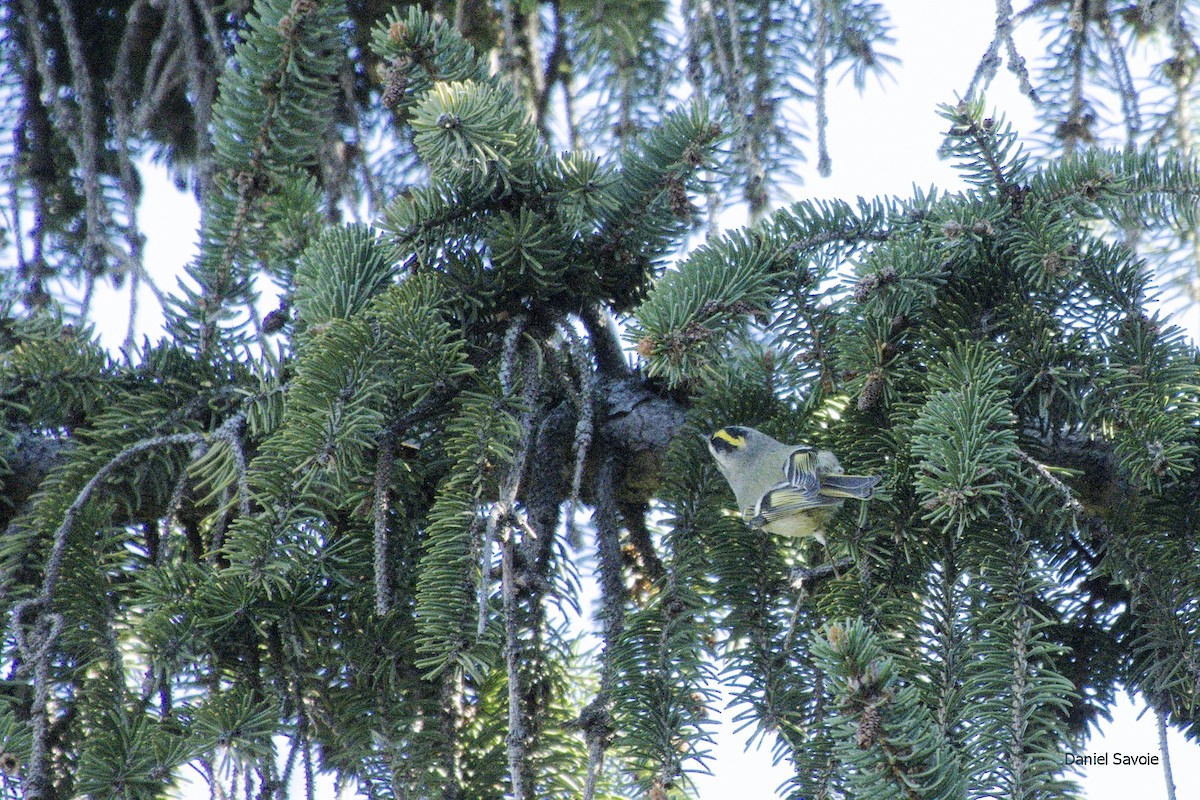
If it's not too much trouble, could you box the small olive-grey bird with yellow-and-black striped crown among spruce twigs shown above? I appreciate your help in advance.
[706,425,880,545]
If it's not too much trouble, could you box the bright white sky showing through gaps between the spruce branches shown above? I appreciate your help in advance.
[72,0,1200,800]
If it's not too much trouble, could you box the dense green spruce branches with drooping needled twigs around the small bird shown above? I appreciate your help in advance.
[0,0,1200,800]
